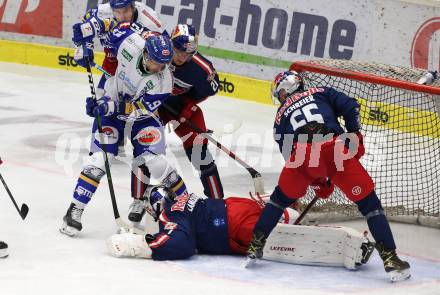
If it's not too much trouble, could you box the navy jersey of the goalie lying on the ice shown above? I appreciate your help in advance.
[148,194,231,260]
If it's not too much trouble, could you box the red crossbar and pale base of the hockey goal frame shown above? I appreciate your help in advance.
[289,60,440,228]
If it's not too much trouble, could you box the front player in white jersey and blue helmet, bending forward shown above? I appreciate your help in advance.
[60,23,186,236]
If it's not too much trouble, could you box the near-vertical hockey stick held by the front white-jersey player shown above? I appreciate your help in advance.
[83,44,142,234]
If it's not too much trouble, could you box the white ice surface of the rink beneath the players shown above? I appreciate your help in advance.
[0,63,440,295]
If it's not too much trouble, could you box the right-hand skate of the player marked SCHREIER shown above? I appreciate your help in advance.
[376,243,411,282]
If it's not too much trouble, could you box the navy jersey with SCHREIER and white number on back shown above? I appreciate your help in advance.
[274,87,360,157]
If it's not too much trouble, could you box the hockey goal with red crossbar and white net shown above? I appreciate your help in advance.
[290,59,440,227]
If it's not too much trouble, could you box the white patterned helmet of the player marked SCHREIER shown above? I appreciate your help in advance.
[271,71,304,103]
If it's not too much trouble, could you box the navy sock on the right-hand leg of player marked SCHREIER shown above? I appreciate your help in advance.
[356,190,396,250]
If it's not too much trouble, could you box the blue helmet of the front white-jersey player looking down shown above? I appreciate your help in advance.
[145,33,173,64]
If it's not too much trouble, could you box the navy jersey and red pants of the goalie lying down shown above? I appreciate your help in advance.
[148,195,262,260]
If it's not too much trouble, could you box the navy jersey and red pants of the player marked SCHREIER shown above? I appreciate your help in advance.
[274,87,374,201]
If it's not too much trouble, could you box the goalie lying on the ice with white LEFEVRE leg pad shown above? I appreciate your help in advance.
[107,186,374,269]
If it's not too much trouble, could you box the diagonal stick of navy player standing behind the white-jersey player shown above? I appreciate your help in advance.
[95,65,264,194]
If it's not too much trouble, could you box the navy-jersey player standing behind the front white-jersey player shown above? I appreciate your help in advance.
[129,24,223,222]
